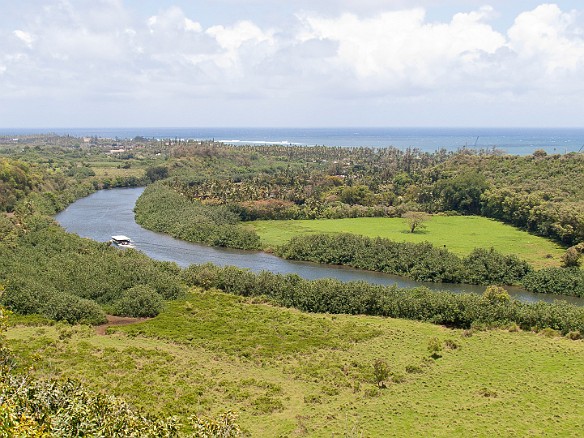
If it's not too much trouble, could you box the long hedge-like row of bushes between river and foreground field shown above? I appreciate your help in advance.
[183,264,584,334]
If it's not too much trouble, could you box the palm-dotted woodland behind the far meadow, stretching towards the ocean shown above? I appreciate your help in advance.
[156,145,584,245]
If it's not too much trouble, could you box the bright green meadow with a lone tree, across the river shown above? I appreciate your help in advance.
[249,216,565,268]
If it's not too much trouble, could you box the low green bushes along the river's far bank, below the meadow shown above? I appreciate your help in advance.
[135,182,580,296]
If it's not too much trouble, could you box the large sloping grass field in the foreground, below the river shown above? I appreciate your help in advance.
[8,291,584,437]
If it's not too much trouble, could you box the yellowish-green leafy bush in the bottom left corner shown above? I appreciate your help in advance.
[0,374,178,438]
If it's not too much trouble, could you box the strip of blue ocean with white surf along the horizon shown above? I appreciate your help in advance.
[0,128,584,155]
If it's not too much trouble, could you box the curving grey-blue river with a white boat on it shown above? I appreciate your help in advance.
[55,188,584,305]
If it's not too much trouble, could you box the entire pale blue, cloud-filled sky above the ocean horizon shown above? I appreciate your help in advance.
[0,0,584,128]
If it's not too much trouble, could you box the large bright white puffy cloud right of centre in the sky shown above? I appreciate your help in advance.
[302,8,505,90]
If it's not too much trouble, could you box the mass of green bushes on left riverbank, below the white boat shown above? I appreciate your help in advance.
[0,216,183,324]
